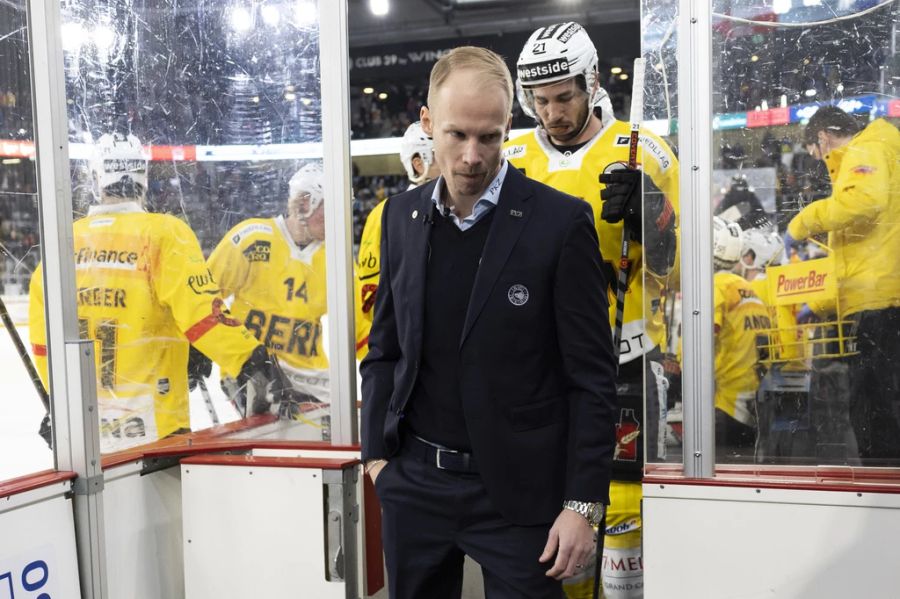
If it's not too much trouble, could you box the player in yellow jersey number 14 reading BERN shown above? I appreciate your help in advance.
[208,163,330,426]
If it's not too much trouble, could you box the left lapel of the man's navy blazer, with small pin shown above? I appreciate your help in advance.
[400,181,436,355]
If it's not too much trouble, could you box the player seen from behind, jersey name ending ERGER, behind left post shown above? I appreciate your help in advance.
[29,134,278,452]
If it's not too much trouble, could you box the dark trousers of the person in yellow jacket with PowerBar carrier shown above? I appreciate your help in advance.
[850,308,900,466]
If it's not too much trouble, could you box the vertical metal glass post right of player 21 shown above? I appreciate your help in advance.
[678,0,716,478]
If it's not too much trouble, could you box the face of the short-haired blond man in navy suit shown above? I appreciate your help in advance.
[421,69,512,200]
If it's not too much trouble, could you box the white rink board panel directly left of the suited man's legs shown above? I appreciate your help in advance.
[181,464,346,599]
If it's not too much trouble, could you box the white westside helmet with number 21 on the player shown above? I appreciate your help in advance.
[516,21,600,119]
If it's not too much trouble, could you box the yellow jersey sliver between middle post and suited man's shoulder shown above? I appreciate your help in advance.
[354,200,387,360]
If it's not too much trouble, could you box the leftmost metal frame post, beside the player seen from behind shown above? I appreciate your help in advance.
[28,0,107,599]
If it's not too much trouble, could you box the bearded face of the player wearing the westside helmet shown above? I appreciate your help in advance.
[532,77,591,144]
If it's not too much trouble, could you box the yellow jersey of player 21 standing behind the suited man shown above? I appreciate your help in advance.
[503,120,679,364]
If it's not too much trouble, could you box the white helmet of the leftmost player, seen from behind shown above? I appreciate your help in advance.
[91,133,148,197]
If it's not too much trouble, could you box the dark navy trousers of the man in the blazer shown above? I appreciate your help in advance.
[375,443,564,599]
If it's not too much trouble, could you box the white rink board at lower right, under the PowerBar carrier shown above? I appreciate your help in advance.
[643,484,900,599]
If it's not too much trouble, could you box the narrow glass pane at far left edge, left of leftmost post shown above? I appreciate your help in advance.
[0,3,53,481]
